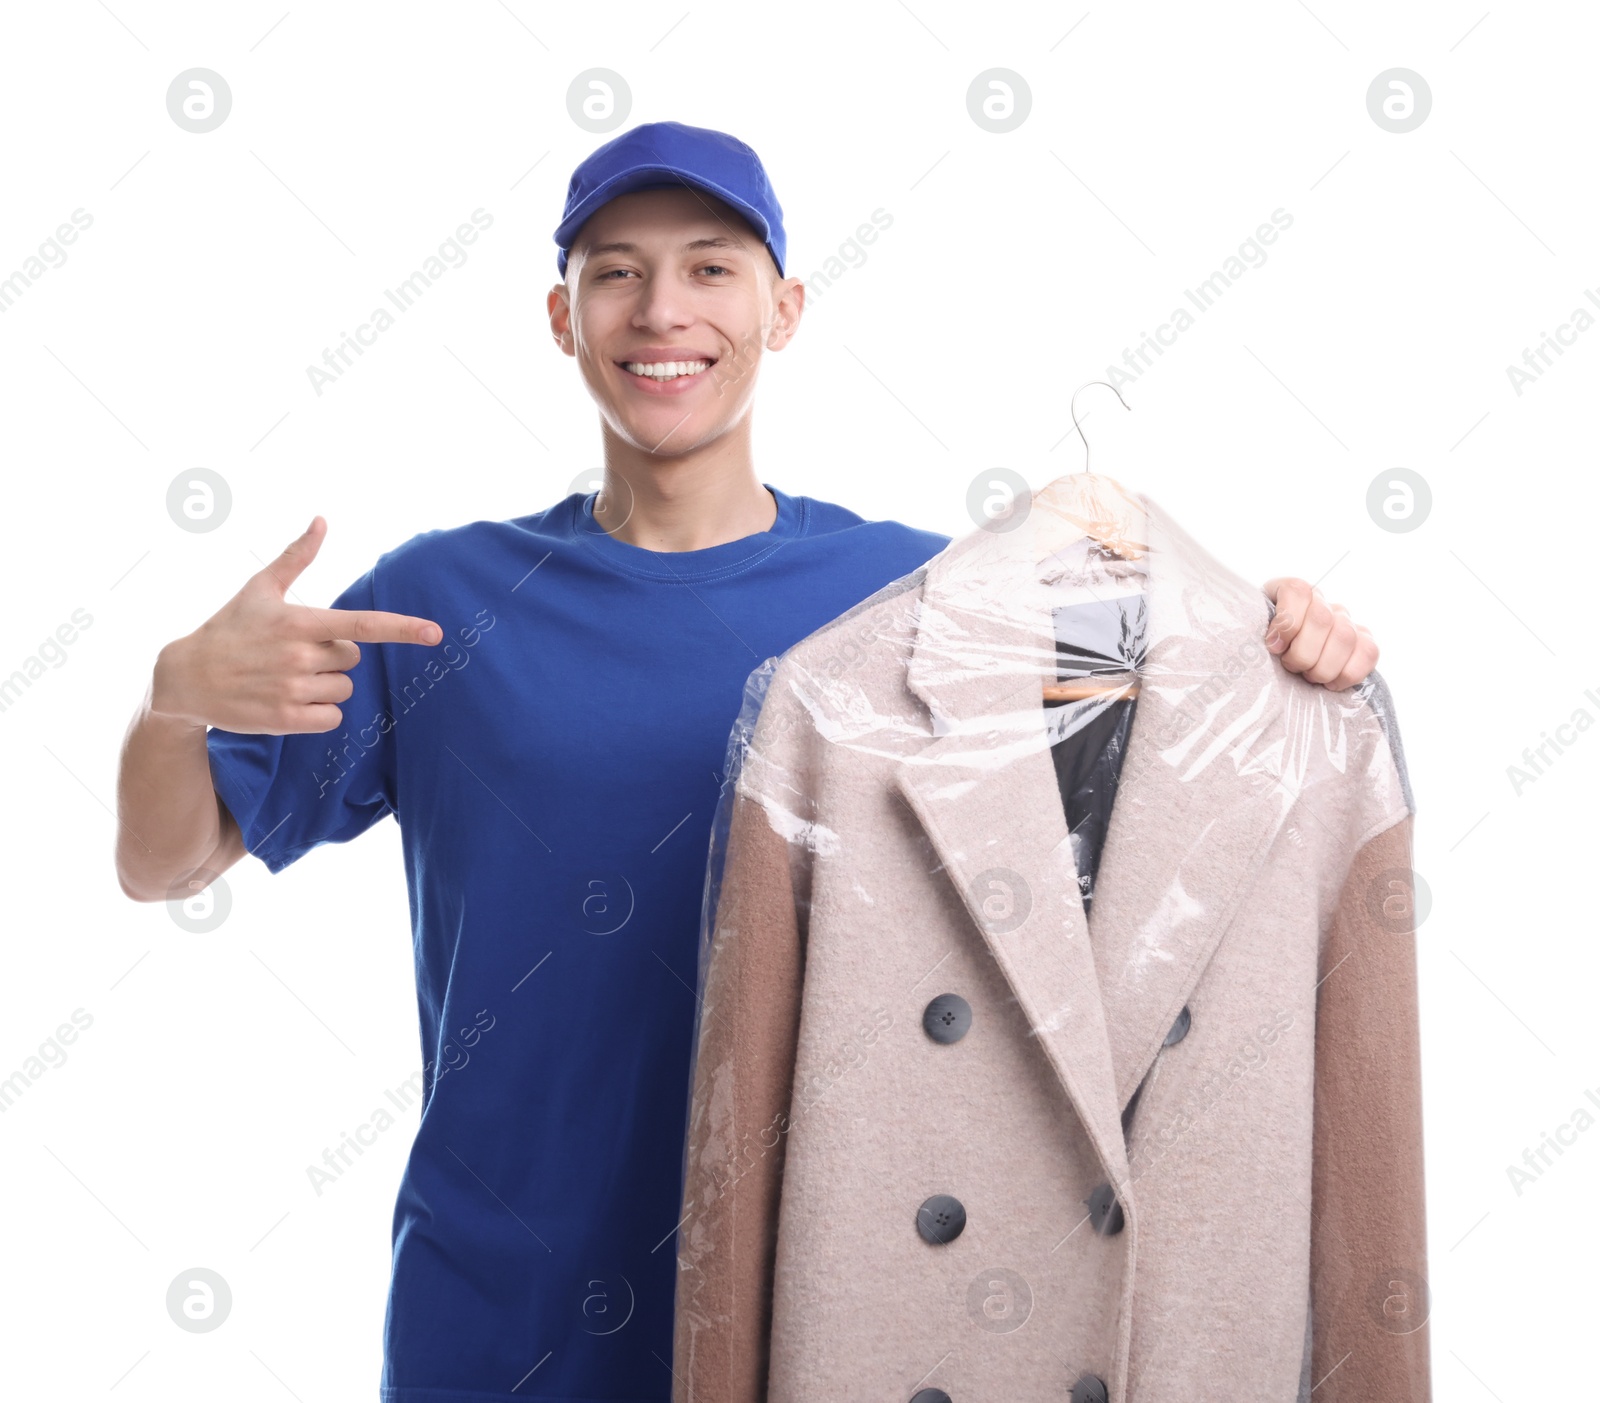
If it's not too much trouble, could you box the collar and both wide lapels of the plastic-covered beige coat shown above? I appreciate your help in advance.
[894,496,1293,1185]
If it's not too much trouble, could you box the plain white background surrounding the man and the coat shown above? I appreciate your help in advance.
[0,0,1600,1403]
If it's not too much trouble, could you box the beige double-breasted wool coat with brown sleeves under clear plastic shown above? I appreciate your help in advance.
[672,486,1429,1403]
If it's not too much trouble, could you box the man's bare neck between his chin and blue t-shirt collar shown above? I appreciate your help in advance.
[595,416,778,552]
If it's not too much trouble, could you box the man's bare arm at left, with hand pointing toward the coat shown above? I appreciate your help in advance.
[117,517,443,901]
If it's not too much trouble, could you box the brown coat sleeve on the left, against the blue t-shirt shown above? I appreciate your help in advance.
[672,793,805,1403]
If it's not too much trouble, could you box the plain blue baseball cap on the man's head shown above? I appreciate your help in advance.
[554,122,787,278]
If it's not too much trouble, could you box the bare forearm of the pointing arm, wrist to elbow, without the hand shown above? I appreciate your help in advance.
[117,649,224,901]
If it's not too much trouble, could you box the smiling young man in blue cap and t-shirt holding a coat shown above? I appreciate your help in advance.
[117,122,1376,1403]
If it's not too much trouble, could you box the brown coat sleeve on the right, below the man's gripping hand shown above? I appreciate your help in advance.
[1302,813,1430,1403]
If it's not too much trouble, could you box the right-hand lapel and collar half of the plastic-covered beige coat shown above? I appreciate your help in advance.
[1090,499,1298,1105]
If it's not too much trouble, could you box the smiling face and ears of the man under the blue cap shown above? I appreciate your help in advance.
[547,187,805,458]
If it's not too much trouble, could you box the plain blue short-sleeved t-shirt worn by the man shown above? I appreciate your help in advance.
[206,488,949,1403]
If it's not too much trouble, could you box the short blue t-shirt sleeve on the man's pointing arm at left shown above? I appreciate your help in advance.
[206,566,398,872]
